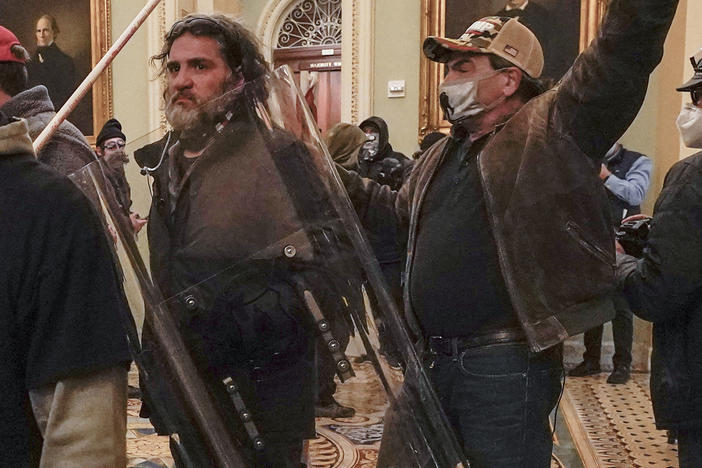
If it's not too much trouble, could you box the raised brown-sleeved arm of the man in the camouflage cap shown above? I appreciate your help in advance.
[552,0,678,161]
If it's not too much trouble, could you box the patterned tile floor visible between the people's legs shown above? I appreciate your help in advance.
[127,363,678,468]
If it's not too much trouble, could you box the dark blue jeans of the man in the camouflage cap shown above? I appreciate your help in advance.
[429,343,563,468]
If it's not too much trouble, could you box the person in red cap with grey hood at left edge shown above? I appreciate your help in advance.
[0,26,96,175]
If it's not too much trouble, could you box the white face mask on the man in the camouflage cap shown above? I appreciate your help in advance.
[439,70,505,124]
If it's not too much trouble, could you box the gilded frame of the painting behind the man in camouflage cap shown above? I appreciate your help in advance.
[418,0,607,140]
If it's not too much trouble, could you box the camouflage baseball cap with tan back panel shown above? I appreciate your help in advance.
[422,16,544,78]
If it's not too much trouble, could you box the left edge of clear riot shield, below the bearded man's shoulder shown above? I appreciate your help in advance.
[69,161,248,467]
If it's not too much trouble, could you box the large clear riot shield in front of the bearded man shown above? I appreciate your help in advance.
[74,67,467,468]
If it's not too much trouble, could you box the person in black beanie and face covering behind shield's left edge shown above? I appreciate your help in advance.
[95,119,146,234]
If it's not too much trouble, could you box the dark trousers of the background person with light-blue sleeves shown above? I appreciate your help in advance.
[583,294,634,368]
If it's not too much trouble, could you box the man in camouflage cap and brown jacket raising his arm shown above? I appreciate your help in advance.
[340,0,677,467]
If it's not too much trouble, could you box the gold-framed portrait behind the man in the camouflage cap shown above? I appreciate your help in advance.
[419,0,606,138]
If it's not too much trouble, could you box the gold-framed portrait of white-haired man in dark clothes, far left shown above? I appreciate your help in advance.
[0,0,112,144]
